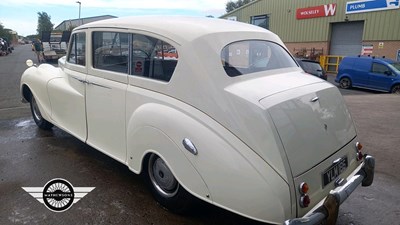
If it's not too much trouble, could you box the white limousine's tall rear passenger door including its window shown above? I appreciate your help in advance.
[86,30,129,163]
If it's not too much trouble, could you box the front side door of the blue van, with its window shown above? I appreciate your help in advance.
[368,62,394,91]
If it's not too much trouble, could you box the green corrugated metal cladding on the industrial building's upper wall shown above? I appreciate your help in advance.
[223,0,400,42]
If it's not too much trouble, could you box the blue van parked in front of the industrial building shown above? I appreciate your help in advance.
[335,56,400,94]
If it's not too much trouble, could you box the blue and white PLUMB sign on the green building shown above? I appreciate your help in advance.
[346,0,400,14]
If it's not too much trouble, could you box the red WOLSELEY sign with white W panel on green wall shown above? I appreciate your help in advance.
[296,4,336,20]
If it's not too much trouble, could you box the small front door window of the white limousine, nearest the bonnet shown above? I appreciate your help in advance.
[67,33,86,66]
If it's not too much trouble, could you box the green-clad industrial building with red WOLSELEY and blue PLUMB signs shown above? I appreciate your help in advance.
[221,0,400,70]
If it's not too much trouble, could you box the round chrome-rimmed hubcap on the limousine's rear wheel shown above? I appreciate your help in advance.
[148,155,179,197]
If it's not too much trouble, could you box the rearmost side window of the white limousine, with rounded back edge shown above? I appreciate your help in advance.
[130,34,178,82]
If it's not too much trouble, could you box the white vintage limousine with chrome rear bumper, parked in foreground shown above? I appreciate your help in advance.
[21,17,375,225]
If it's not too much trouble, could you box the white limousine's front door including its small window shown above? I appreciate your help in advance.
[47,31,87,141]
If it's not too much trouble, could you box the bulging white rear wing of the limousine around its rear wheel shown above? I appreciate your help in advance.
[127,103,292,223]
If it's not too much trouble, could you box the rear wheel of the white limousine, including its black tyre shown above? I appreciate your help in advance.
[143,154,195,213]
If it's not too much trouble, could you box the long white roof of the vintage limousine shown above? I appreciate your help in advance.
[74,16,281,43]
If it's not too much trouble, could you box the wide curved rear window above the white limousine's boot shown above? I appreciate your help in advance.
[221,40,298,77]
